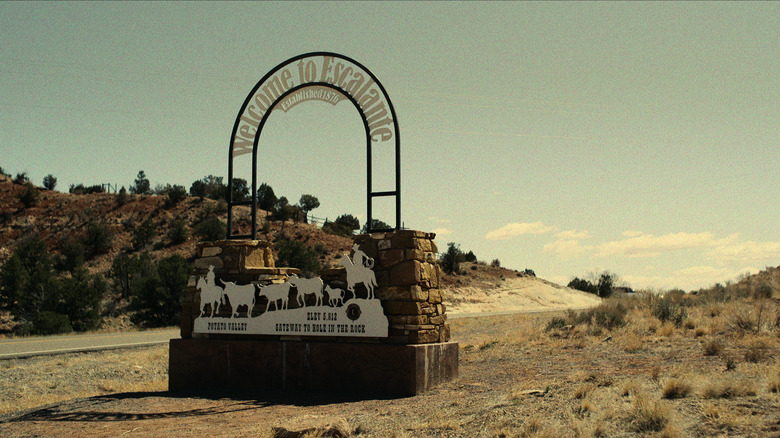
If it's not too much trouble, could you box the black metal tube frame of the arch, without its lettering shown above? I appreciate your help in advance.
[226,52,401,240]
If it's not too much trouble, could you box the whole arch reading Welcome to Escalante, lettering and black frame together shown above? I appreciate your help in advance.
[227,52,401,239]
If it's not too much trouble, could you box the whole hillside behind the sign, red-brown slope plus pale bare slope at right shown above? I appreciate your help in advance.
[0,176,600,332]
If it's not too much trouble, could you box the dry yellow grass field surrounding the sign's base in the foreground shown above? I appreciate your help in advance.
[0,294,780,437]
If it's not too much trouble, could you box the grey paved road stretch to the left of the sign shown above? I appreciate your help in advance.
[0,328,180,360]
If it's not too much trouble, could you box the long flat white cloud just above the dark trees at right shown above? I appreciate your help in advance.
[598,232,718,257]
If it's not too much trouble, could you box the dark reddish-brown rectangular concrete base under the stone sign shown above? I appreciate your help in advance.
[168,339,458,396]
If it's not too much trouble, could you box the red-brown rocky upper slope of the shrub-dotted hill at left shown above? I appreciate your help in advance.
[0,176,351,272]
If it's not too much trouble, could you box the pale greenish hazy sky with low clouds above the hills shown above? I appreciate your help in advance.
[0,2,780,291]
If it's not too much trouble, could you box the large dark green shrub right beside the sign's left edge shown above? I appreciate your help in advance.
[130,255,190,327]
